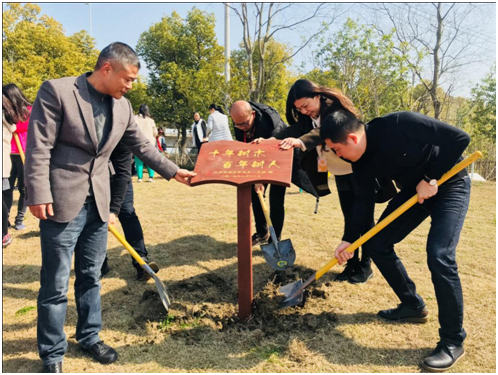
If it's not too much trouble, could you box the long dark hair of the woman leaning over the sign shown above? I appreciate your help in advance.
[285,79,358,125]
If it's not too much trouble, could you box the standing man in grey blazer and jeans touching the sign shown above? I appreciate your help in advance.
[25,42,195,372]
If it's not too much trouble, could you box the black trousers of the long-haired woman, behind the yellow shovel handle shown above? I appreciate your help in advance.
[335,173,374,262]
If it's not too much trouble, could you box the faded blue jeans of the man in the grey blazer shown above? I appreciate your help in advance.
[37,202,107,365]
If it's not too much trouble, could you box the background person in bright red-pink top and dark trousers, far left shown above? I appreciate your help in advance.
[2,83,31,230]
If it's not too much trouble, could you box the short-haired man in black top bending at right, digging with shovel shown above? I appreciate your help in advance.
[320,111,471,372]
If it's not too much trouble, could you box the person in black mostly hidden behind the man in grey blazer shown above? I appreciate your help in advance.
[101,142,159,281]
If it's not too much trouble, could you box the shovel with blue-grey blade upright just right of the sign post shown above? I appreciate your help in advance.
[258,191,296,271]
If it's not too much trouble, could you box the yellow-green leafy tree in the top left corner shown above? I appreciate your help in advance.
[2,3,98,101]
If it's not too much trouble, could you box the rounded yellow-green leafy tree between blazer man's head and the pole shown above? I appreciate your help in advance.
[137,7,224,160]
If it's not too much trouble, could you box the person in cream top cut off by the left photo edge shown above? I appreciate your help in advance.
[2,95,16,248]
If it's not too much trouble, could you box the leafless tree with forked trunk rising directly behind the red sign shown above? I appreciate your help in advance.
[230,3,344,102]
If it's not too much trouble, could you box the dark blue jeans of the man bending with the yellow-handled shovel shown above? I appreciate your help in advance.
[364,176,471,345]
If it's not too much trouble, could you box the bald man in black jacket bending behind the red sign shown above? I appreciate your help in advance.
[230,100,286,246]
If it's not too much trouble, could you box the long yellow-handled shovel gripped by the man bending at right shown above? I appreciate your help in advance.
[280,151,482,307]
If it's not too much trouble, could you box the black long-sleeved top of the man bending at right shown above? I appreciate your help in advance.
[345,112,470,242]
